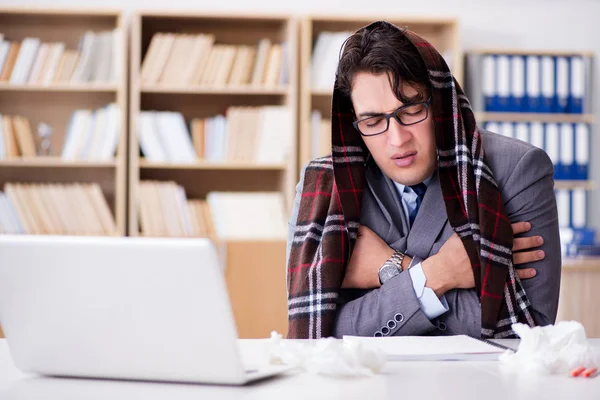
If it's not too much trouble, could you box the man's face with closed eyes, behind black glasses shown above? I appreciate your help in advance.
[352,72,437,185]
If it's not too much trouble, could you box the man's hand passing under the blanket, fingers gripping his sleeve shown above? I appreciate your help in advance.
[421,222,545,297]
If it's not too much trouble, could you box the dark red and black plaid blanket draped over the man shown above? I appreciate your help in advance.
[288,23,535,338]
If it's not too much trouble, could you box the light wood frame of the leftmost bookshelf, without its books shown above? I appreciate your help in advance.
[0,7,128,235]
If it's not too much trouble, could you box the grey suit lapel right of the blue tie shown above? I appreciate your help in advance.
[407,173,448,259]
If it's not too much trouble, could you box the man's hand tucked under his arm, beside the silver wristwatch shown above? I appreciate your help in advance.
[342,225,394,289]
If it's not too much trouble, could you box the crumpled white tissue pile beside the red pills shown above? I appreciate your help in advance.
[500,321,600,375]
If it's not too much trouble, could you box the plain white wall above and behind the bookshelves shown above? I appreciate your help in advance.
[0,0,600,229]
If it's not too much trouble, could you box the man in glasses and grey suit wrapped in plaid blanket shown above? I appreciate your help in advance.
[288,22,561,338]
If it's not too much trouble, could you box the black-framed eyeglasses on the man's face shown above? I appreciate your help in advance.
[352,96,431,136]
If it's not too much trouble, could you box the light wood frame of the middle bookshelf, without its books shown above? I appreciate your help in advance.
[128,11,297,236]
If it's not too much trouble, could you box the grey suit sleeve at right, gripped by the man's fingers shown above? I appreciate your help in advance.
[502,148,562,325]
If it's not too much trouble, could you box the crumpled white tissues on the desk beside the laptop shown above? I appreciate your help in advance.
[269,332,386,377]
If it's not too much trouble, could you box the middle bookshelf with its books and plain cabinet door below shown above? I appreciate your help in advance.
[128,11,298,338]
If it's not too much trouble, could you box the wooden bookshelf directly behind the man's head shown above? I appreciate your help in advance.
[298,15,463,168]
